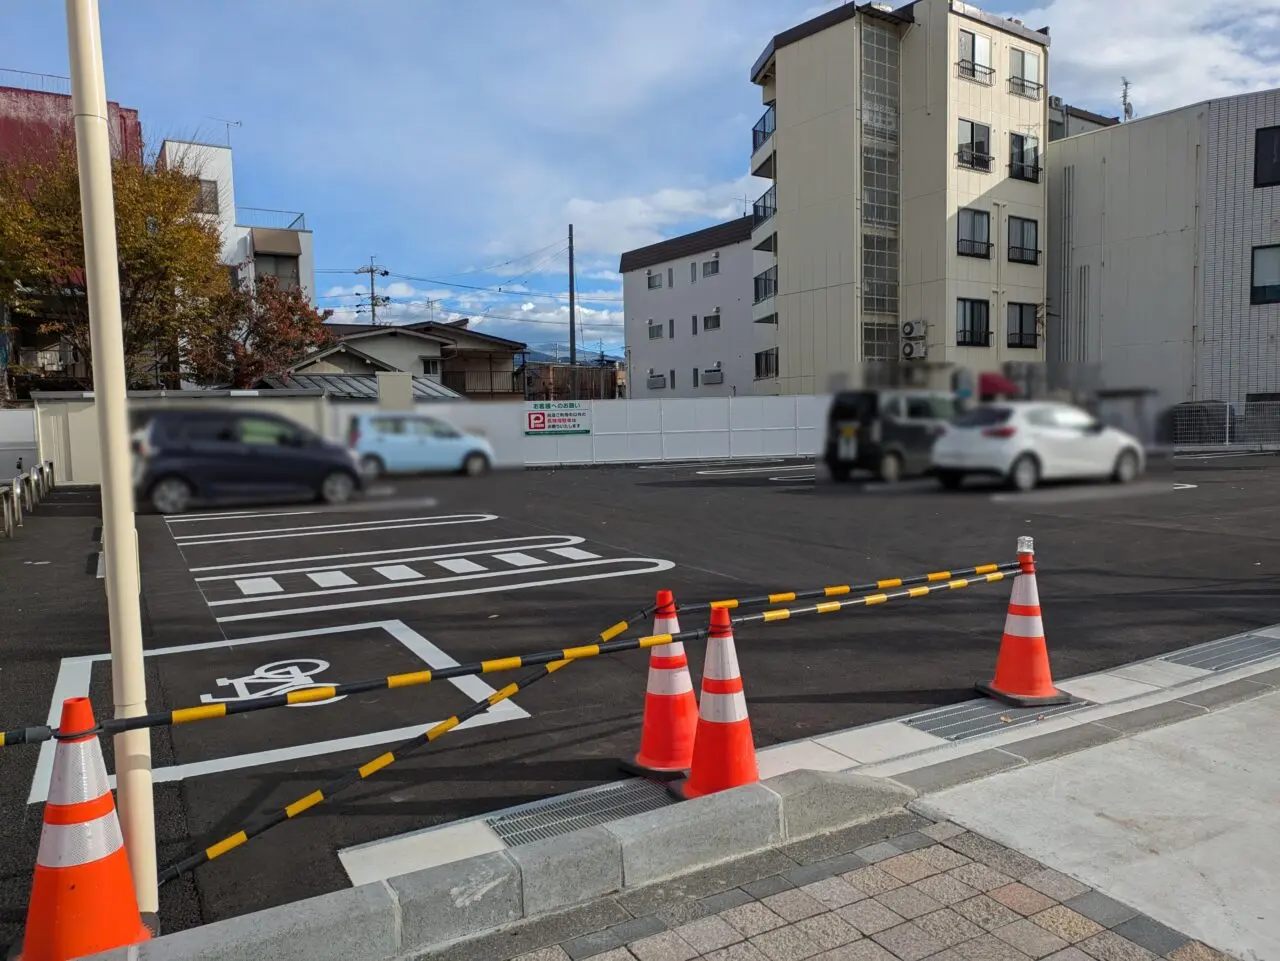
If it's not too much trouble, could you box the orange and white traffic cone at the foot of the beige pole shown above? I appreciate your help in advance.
[18,697,151,961]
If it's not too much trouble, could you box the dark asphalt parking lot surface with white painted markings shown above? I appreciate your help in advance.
[0,458,1280,930]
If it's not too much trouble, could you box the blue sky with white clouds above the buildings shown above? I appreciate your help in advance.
[0,0,1280,349]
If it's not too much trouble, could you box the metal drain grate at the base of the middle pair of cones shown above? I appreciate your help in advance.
[485,778,676,847]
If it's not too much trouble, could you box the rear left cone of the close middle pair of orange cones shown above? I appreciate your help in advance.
[622,591,698,781]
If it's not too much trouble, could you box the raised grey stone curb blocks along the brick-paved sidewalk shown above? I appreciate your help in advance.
[93,770,915,961]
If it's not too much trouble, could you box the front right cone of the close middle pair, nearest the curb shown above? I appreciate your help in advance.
[676,608,760,798]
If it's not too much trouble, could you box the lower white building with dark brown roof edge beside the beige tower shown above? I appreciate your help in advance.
[618,216,777,398]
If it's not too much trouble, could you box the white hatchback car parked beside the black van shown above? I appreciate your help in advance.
[932,401,1146,490]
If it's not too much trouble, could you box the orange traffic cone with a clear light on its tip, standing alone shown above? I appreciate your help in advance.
[978,537,1075,708]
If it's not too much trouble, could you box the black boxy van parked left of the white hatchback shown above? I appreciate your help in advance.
[823,389,956,484]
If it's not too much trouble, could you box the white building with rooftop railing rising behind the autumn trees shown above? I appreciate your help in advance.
[160,139,316,303]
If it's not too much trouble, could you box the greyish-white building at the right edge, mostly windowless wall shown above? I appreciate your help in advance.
[1048,83,1280,403]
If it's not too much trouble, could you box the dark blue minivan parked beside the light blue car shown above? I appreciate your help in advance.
[133,409,364,514]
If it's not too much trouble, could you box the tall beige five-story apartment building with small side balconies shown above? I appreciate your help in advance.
[750,0,1048,394]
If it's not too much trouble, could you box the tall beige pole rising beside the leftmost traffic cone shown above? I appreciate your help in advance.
[67,0,159,920]
